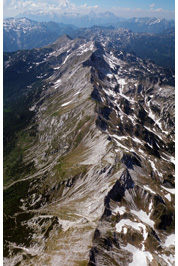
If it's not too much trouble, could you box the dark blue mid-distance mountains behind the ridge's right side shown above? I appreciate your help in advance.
[70,26,175,70]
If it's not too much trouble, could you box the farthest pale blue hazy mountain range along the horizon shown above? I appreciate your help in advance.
[17,11,175,33]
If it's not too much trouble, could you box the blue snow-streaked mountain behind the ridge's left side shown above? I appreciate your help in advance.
[3,18,77,52]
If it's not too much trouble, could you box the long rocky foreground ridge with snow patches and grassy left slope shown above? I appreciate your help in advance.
[4,35,175,266]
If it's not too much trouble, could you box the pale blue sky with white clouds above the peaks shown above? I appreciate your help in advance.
[3,0,175,19]
